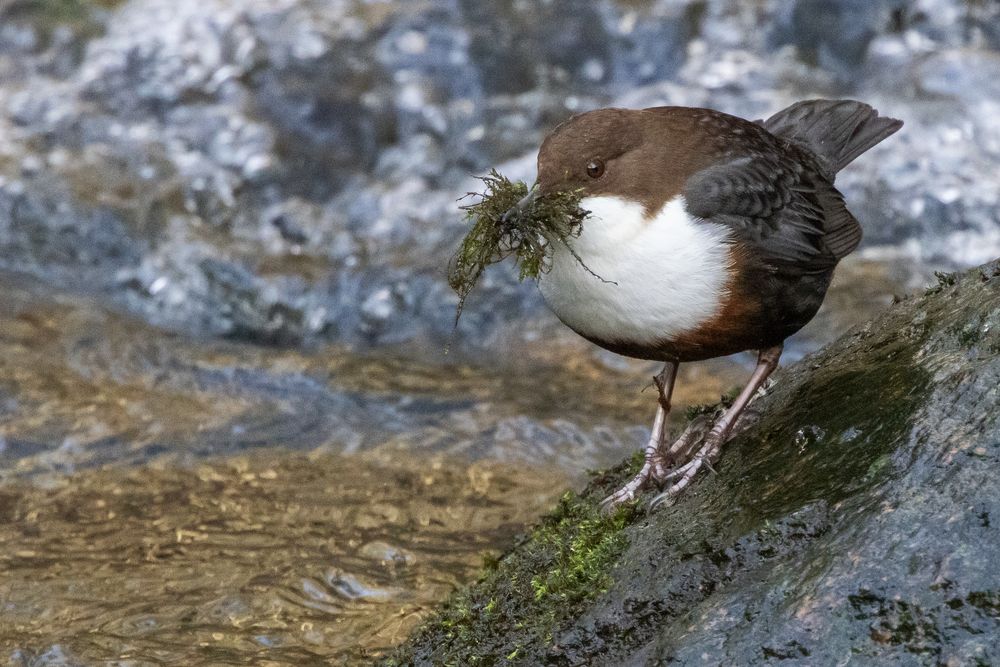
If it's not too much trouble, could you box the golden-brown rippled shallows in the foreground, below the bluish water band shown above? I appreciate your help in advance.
[0,451,566,665]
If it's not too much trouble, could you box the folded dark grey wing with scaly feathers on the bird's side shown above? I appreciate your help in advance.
[684,150,861,273]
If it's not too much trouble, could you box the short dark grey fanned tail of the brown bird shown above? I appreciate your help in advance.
[763,100,903,177]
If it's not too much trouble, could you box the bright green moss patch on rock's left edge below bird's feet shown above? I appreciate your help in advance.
[383,492,637,665]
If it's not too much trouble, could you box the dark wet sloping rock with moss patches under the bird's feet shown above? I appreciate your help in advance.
[384,260,1000,665]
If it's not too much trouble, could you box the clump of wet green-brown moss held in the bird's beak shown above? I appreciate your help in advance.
[448,170,592,323]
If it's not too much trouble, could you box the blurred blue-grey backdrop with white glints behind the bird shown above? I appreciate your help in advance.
[0,0,1000,358]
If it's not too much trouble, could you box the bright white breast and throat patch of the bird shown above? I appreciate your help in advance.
[538,197,731,345]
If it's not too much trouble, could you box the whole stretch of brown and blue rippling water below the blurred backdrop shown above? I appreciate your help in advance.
[0,262,916,665]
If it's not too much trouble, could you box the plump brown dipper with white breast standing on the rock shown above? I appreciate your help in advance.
[509,99,903,508]
